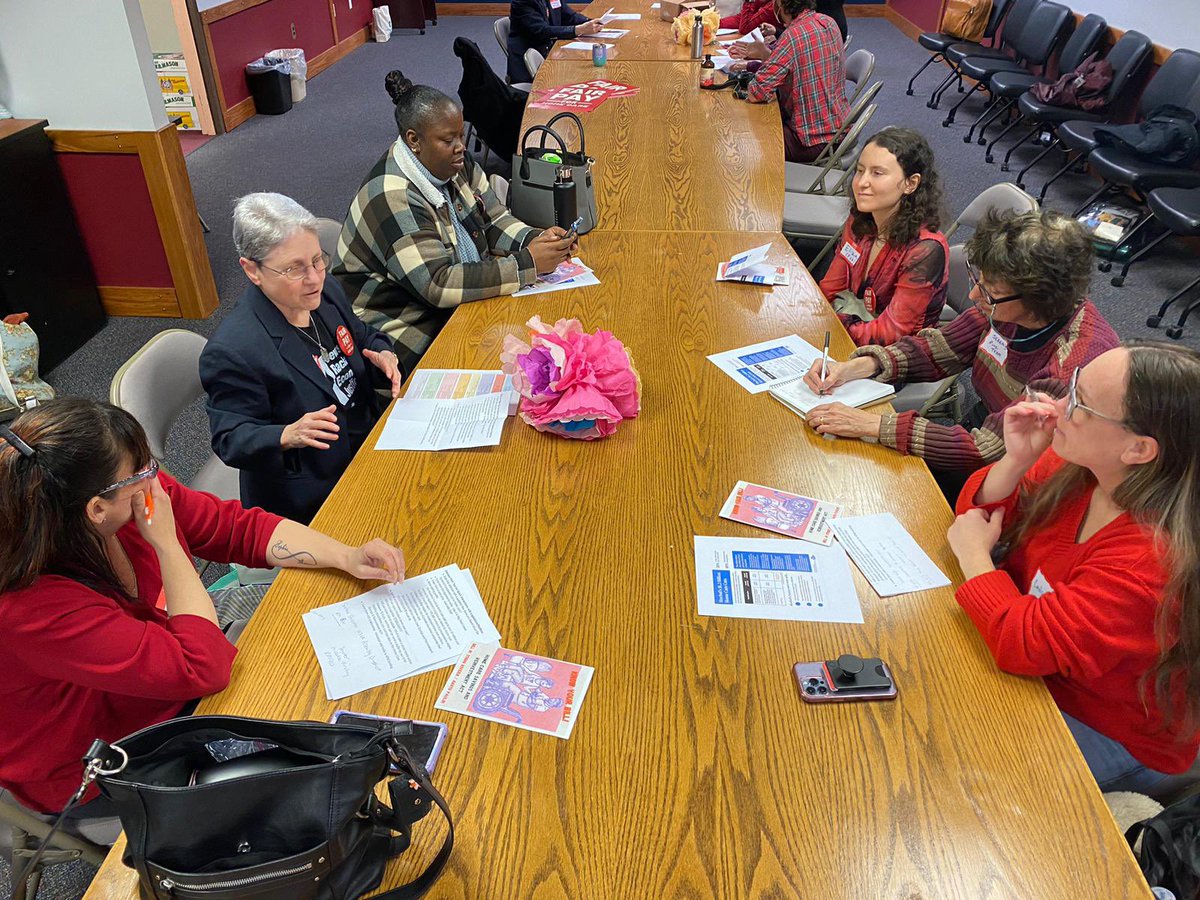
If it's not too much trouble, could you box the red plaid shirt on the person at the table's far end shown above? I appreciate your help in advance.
[749,10,850,146]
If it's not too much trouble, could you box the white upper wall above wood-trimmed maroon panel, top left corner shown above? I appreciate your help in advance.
[0,0,167,131]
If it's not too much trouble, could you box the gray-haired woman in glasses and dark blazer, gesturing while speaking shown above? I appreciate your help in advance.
[200,193,403,523]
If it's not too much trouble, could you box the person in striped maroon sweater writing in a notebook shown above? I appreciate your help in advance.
[804,210,1118,497]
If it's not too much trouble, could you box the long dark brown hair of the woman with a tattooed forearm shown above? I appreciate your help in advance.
[0,397,150,600]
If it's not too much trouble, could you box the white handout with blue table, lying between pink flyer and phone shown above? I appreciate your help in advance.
[695,535,863,623]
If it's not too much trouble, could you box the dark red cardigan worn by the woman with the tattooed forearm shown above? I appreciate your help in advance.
[0,473,282,812]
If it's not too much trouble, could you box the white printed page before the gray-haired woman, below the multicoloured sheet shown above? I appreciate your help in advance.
[374,391,511,450]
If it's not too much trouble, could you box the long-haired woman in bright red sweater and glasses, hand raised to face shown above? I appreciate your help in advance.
[947,343,1200,791]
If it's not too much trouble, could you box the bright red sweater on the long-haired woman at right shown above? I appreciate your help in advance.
[958,450,1200,774]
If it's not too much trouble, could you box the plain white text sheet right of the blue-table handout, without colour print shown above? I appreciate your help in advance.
[832,512,950,596]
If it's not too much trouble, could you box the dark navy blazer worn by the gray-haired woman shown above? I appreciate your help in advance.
[200,277,392,523]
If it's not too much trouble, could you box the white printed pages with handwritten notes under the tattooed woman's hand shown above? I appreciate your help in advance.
[301,565,500,700]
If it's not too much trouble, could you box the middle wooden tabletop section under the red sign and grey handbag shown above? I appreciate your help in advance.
[522,61,784,234]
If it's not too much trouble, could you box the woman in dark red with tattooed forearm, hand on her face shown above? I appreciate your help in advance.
[0,398,404,818]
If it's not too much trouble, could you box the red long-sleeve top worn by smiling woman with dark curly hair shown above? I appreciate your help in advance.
[821,221,950,347]
